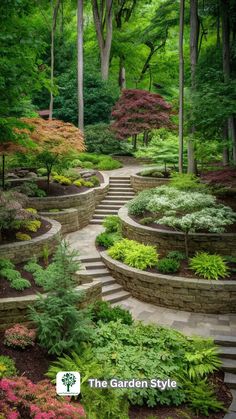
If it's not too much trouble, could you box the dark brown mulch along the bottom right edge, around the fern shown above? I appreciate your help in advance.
[129,371,232,419]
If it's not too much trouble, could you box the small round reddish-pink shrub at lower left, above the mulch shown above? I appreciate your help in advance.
[4,324,36,349]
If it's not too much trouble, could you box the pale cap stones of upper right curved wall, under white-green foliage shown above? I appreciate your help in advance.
[118,206,236,240]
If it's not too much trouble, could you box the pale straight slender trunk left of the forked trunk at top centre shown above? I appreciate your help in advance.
[77,0,84,131]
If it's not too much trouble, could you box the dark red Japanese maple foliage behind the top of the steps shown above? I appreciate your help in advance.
[111,89,173,140]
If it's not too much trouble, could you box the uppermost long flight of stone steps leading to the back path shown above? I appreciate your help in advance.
[90,176,134,224]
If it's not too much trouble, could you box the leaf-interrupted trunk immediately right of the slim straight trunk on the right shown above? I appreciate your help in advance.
[188,0,199,173]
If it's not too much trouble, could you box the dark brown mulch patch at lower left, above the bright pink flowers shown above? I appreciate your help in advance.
[0,332,53,383]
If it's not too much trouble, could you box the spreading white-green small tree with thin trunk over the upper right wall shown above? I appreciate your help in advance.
[128,185,236,257]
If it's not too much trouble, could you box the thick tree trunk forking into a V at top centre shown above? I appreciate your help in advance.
[92,0,113,80]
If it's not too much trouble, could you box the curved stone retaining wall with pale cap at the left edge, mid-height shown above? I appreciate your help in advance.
[0,218,61,263]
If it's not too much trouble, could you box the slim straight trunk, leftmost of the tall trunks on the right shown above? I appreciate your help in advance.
[179,0,185,173]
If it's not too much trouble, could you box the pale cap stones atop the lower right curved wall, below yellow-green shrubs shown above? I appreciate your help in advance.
[100,251,236,291]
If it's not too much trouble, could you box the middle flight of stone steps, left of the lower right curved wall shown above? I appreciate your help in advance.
[79,257,130,304]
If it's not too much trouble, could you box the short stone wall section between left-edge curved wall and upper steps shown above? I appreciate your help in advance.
[40,208,79,234]
